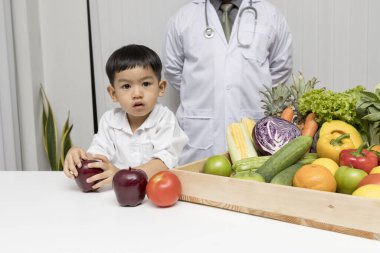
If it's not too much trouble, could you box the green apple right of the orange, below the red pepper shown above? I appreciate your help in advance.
[334,166,368,194]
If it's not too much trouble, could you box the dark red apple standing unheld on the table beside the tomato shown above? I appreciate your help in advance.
[112,168,148,206]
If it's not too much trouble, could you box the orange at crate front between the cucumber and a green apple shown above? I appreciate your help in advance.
[293,164,336,192]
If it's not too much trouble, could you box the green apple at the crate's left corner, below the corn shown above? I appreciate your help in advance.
[202,155,231,177]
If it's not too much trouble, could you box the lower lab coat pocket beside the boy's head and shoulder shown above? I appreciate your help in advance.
[183,109,214,149]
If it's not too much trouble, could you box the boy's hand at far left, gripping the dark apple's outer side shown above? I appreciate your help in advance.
[63,147,89,179]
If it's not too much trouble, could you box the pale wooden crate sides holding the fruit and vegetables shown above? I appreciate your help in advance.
[172,156,380,240]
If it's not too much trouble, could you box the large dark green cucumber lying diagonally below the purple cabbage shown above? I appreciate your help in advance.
[256,136,313,182]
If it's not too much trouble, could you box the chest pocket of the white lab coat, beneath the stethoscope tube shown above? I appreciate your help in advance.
[239,24,271,65]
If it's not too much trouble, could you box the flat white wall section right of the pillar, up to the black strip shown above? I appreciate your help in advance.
[39,0,94,149]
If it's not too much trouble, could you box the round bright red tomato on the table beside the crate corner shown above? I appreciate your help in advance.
[146,170,182,207]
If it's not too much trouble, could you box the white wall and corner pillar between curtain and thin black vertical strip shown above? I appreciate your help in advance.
[12,0,93,170]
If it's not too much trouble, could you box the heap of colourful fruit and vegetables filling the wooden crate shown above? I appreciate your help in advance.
[203,75,380,199]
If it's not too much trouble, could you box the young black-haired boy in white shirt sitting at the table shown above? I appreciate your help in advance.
[64,45,188,189]
